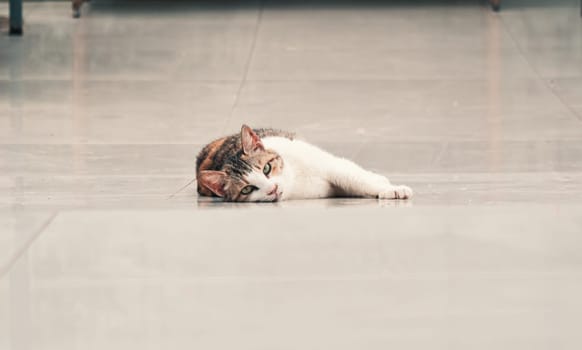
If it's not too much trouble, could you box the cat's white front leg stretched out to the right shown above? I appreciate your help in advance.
[328,156,412,199]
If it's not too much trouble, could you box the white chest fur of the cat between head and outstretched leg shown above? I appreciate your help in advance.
[263,137,333,199]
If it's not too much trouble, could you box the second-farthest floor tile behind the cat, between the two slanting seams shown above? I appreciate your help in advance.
[249,49,535,80]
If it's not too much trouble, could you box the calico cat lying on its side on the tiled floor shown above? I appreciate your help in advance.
[196,125,412,202]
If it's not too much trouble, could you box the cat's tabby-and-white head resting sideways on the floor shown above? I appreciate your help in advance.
[198,125,284,202]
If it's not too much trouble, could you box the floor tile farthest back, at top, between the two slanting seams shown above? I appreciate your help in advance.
[257,3,513,51]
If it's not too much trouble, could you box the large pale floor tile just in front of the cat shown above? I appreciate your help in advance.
[16,208,582,283]
